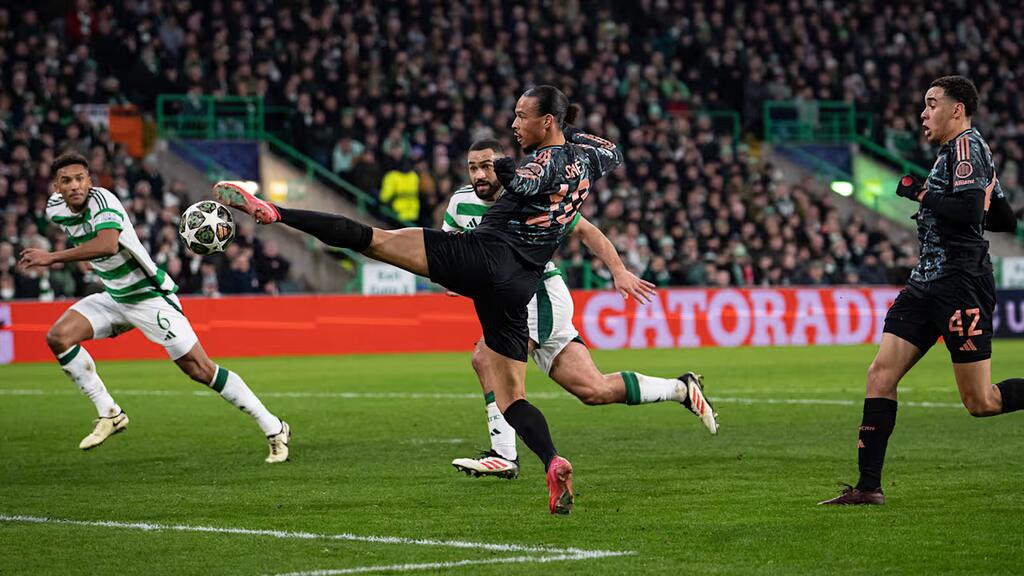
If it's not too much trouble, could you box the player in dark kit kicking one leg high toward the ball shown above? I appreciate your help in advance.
[214,86,623,513]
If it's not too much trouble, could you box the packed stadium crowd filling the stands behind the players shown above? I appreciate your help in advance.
[0,0,1024,297]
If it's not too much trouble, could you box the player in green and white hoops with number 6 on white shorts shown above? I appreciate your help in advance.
[18,152,290,463]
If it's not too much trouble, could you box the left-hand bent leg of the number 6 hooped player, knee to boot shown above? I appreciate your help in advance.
[46,310,128,450]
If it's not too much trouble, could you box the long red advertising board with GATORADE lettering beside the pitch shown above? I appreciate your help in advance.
[6,286,1024,364]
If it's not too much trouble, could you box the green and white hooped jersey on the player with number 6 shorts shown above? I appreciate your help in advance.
[46,188,178,304]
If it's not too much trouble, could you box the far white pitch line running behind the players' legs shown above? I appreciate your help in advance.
[0,388,963,408]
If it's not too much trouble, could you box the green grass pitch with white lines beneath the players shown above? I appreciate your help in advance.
[0,341,1024,576]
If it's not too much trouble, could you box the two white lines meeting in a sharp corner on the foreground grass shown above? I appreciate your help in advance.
[0,513,636,576]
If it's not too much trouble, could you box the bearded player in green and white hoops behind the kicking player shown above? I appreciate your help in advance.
[441,138,718,479]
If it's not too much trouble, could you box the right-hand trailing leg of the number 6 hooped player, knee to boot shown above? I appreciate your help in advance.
[174,343,292,464]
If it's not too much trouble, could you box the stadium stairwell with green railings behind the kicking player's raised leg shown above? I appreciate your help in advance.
[157,94,410,292]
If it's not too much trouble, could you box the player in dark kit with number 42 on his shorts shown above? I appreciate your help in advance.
[820,76,1024,504]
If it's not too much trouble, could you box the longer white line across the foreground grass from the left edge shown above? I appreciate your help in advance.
[0,513,635,558]
